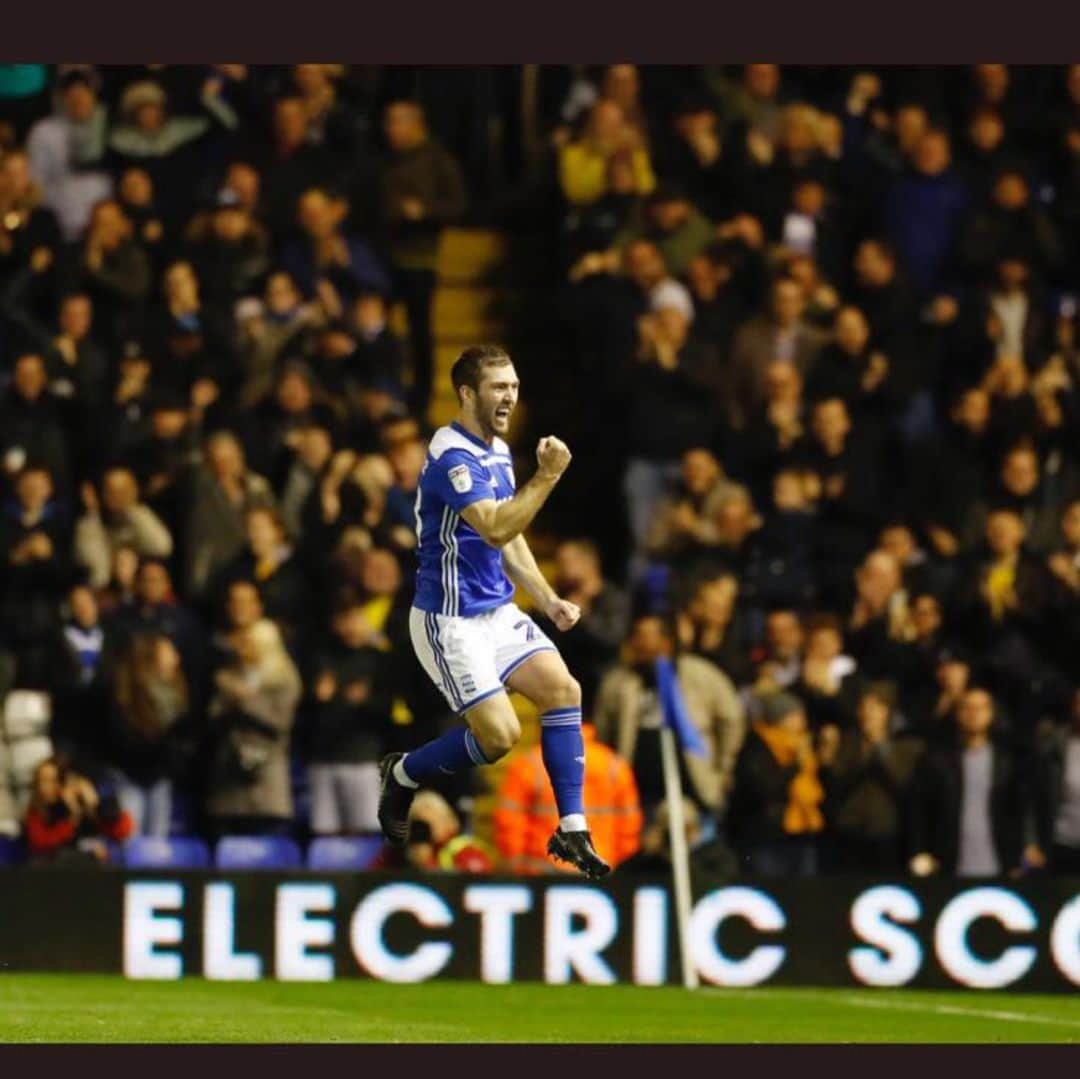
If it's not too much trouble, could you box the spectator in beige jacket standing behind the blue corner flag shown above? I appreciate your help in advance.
[593,615,744,813]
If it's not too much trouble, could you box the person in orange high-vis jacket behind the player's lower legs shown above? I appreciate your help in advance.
[494,724,642,873]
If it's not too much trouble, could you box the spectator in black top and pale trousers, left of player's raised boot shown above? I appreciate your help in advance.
[306,599,392,835]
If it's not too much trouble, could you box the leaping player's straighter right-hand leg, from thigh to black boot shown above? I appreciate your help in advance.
[507,651,611,879]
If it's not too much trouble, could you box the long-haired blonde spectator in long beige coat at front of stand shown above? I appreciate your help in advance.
[204,619,302,836]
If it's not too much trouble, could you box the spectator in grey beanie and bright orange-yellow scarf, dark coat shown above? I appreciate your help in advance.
[728,692,825,876]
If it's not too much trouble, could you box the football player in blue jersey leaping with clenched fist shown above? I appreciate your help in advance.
[379,346,610,878]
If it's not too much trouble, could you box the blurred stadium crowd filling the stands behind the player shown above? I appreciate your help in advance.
[0,64,1080,877]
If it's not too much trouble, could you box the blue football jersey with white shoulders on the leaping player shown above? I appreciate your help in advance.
[413,423,514,618]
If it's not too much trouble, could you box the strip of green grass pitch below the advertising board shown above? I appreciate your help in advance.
[0,973,1080,1043]
